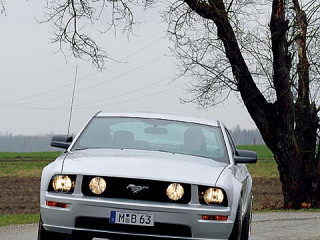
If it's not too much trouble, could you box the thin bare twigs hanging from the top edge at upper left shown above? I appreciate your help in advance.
[43,0,153,69]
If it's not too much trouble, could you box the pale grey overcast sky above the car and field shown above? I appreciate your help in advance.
[0,0,255,134]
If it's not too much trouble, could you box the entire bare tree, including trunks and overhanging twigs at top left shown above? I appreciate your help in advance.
[30,0,320,208]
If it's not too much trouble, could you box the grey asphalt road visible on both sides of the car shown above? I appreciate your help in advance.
[0,212,320,240]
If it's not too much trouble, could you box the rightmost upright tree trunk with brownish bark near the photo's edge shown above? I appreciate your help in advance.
[292,0,319,207]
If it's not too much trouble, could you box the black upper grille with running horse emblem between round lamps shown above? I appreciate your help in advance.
[82,176,191,203]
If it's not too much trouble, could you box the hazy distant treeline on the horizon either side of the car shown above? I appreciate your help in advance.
[0,126,264,152]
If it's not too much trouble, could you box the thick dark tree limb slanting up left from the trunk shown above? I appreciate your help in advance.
[185,0,272,132]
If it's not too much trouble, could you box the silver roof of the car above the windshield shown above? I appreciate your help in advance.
[96,112,220,127]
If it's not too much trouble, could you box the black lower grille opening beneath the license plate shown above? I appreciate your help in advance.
[75,217,192,237]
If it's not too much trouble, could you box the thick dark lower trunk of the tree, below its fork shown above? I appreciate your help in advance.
[260,108,320,209]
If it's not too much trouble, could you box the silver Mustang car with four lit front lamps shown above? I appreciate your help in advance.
[38,112,257,240]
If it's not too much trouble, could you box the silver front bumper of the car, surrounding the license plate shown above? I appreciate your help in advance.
[40,191,233,240]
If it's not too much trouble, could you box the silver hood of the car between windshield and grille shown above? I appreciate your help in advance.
[63,149,227,185]
